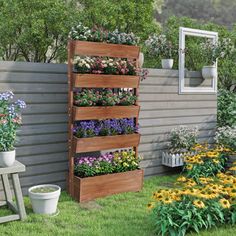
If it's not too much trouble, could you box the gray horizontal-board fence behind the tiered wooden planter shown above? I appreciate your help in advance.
[0,62,217,192]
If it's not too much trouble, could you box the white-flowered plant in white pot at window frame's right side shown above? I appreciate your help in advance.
[201,38,234,79]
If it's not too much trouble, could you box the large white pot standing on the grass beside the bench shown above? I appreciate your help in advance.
[28,184,61,214]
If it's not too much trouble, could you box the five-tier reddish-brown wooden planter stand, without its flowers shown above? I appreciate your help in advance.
[68,41,143,202]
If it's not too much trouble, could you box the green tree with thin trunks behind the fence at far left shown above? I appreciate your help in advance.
[0,0,80,63]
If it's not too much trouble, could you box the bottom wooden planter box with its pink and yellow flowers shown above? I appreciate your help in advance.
[74,150,143,202]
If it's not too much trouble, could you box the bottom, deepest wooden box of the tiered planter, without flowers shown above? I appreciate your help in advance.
[74,170,143,202]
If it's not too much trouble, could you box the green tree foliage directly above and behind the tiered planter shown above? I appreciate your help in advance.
[79,0,160,39]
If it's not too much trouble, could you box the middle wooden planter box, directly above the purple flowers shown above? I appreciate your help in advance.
[73,105,140,120]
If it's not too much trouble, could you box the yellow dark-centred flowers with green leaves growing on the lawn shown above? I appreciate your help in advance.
[148,145,236,235]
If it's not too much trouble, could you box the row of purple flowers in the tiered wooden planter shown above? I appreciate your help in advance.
[73,118,138,138]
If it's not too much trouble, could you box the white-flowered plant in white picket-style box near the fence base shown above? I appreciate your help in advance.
[162,126,198,167]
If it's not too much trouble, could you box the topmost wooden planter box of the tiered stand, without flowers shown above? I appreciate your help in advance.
[70,41,139,59]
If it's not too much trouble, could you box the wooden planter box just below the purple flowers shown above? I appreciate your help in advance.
[73,133,140,153]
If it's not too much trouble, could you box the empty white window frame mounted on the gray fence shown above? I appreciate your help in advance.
[179,27,218,94]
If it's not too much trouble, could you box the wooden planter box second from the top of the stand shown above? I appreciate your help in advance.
[73,73,140,88]
